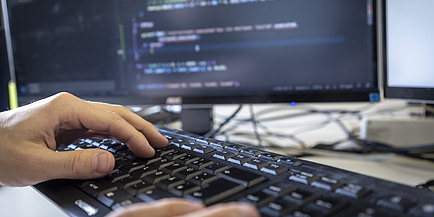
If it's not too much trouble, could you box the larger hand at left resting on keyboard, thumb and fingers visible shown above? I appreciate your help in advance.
[0,93,168,186]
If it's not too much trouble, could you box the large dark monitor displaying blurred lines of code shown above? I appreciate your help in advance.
[3,0,378,105]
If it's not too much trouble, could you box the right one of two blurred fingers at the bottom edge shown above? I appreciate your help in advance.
[183,202,261,217]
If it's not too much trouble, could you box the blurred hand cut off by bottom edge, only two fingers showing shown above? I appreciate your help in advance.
[106,198,260,217]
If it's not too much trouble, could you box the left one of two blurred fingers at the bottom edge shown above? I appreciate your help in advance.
[106,198,204,217]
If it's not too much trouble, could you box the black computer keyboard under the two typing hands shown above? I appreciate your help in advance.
[34,128,434,217]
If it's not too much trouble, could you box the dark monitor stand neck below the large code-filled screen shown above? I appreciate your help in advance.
[181,105,213,135]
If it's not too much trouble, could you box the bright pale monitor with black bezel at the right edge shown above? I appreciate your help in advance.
[383,0,434,103]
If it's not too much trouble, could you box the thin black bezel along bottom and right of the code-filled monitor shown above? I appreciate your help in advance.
[2,0,380,105]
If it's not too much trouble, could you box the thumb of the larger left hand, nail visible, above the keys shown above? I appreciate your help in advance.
[51,149,115,179]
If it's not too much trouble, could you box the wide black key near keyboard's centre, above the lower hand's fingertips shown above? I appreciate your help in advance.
[217,168,266,187]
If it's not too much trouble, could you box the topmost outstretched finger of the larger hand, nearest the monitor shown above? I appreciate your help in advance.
[90,102,168,148]
